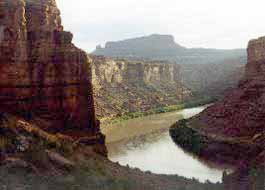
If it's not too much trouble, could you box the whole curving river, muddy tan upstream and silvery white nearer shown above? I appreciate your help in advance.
[102,106,232,182]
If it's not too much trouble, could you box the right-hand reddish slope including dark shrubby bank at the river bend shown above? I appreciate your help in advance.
[171,37,265,170]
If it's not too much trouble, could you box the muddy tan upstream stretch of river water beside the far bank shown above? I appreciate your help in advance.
[101,106,206,143]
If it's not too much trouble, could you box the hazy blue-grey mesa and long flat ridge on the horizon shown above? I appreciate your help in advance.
[92,34,246,64]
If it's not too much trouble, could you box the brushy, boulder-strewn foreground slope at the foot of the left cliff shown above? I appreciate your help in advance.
[0,113,222,190]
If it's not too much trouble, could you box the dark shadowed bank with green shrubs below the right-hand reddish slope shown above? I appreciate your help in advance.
[170,119,265,190]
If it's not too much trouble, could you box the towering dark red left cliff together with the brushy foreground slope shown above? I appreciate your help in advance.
[0,0,227,190]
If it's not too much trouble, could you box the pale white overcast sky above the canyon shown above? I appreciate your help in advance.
[57,0,265,52]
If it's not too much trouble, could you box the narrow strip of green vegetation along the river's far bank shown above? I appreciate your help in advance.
[100,97,213,124]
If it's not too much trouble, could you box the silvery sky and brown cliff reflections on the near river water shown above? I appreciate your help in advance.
[107,130,231,182]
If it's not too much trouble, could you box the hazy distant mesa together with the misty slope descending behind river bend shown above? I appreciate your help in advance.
[92,34,246,98]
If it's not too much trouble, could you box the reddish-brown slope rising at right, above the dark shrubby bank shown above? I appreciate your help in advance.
[189,37,265,140]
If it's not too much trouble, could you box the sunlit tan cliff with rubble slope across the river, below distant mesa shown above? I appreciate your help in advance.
[92,56,191,117]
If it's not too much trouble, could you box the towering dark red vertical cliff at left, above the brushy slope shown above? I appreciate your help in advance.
[0,0,98,135]
